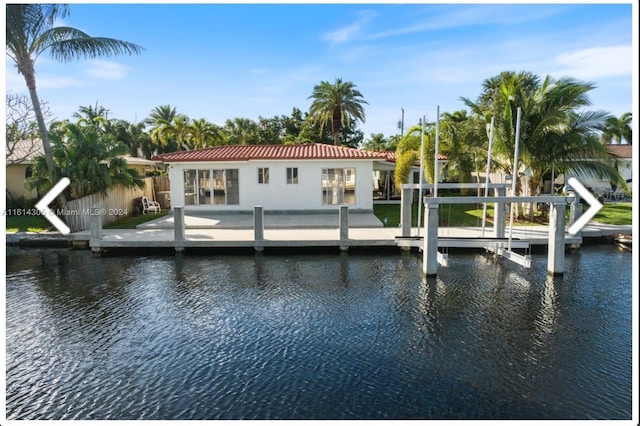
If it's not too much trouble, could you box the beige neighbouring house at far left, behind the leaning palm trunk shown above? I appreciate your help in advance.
[6,139,44,199]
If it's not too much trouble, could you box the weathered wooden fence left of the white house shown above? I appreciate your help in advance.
[62,177,155,232]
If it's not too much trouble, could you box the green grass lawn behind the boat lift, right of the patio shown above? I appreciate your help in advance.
[373,203,632,227]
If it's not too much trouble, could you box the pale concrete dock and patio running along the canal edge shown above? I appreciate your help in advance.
[6,213,632,249]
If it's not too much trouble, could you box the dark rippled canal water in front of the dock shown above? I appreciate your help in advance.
[6,245,632,419]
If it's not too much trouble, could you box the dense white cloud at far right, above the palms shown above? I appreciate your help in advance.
[552,45,633,80]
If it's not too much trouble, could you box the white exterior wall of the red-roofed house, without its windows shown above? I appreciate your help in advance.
[169,160,373,211]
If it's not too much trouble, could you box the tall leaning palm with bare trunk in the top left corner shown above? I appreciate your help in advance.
[6,3,143,183]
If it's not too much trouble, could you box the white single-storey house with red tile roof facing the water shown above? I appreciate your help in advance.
[153,143,389,211]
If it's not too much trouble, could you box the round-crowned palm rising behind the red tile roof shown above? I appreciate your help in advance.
[308,78,367,145]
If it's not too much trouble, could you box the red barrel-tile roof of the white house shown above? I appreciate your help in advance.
[152,143,387,163]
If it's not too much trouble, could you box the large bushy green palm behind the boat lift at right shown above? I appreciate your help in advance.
[462,72,620,216]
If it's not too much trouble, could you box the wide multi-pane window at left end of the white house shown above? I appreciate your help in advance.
[184,169,240,206]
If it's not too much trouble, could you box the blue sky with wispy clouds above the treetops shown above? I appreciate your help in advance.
[6,3,638,137]
